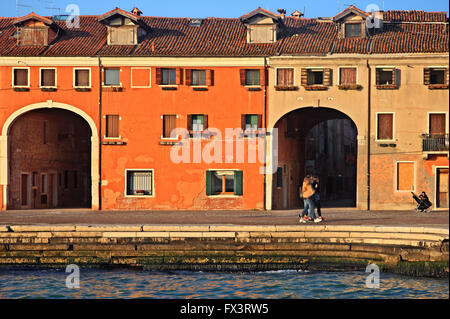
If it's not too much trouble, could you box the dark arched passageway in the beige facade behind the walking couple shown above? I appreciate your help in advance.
[272,107,358,209]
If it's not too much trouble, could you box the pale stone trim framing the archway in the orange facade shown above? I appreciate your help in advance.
[0,101,100,210]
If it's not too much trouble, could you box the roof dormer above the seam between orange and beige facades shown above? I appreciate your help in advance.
[241,8,282,43]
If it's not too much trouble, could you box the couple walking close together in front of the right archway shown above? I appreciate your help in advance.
[300,174,323,223]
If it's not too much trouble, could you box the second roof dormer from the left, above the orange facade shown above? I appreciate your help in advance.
[98,8,147,45]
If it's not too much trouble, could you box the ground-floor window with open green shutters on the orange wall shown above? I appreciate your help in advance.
[206,170,243,196]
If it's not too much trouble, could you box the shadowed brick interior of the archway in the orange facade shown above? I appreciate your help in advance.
[8,109,91,209]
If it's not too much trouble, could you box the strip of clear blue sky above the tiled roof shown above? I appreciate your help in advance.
[4,0,449,18]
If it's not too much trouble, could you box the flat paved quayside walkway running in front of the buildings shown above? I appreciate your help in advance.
[0,208,449,229]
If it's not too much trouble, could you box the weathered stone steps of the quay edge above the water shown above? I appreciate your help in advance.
[0,225,449,277]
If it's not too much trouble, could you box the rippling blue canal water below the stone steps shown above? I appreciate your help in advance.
[0,268,449,299]
